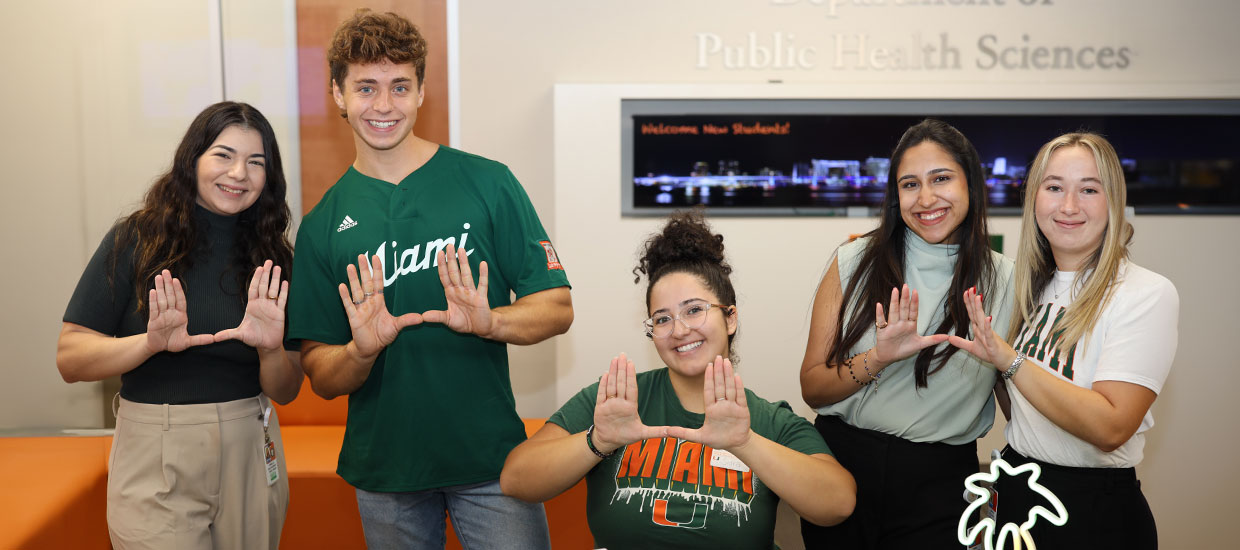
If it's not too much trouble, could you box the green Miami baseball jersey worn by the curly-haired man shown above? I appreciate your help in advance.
[288,146,568,492]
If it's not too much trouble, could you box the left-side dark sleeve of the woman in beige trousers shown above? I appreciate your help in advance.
[63,222,133,336]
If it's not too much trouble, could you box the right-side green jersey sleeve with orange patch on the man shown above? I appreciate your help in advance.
[492,167,569,299]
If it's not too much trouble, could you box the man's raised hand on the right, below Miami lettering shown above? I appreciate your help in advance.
[422,244,491,338]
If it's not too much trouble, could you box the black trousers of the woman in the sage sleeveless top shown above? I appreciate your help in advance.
[801,416,977,550]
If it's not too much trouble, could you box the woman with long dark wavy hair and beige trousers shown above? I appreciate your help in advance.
[56,102,303,549]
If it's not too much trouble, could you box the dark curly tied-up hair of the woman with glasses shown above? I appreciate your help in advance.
[632,208,740,363]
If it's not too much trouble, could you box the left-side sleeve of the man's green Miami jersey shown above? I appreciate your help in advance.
[288,216,353,346]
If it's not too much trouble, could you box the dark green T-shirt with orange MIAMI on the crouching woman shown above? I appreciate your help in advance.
[547,368,831,550]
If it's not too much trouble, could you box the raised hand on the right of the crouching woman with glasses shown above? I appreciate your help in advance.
[667,356,751,451]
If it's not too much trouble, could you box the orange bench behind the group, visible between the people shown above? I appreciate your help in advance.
[0,396,594,550]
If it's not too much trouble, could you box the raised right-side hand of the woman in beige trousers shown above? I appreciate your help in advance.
[215,260,289,349]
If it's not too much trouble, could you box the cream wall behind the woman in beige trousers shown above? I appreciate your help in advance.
[0,0,300,430]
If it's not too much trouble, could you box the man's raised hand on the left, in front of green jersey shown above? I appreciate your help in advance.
[337,254,422,358]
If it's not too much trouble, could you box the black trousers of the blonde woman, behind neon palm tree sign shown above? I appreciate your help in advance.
[996,447,1158,550]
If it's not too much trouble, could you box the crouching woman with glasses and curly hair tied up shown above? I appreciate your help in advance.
[500,208,856,549]
